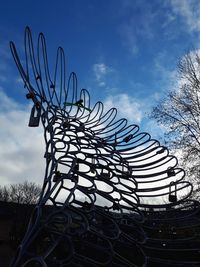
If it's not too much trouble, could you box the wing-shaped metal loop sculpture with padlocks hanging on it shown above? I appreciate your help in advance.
[10,28,198,267]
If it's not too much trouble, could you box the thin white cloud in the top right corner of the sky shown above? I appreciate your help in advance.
[170,0,200,32]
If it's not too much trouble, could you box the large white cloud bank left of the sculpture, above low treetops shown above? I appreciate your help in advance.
[0,90,45,185]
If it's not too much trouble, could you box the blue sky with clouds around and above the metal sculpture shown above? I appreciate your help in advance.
[0,0,200,184]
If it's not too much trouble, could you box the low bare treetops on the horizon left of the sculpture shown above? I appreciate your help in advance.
[0,181,41,204]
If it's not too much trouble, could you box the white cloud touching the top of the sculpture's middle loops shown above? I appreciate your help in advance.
[104,94,143,123]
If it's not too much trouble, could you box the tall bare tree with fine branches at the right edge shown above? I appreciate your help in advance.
[151,51,200,197]
